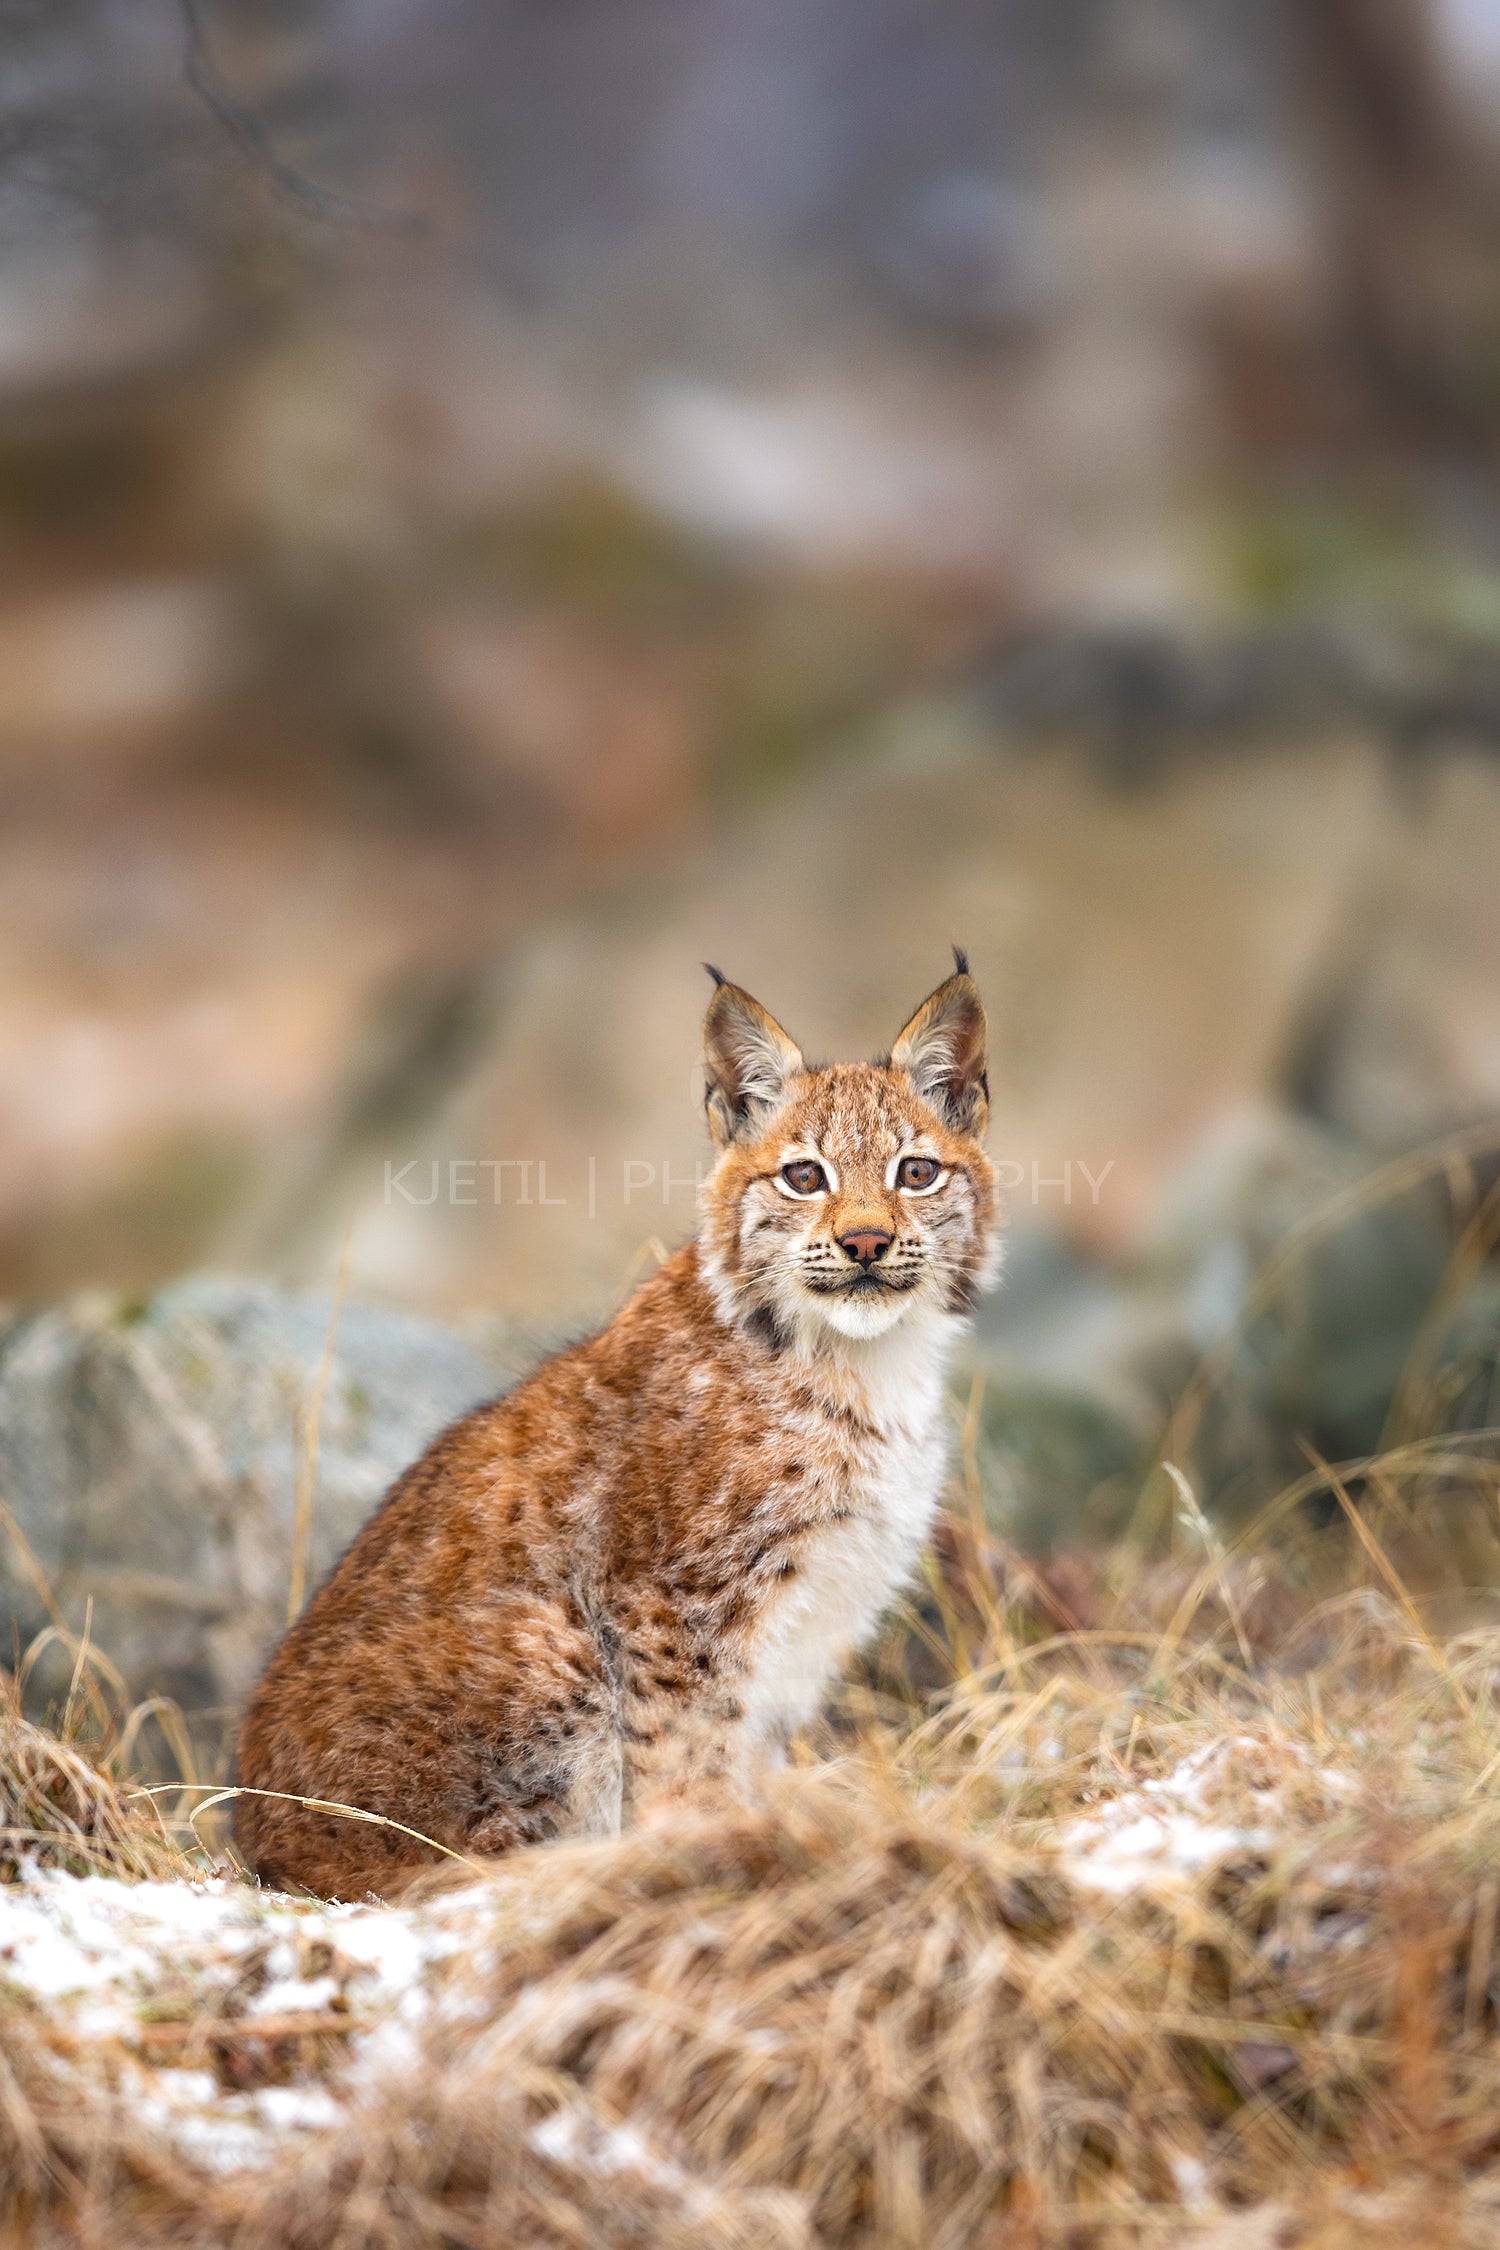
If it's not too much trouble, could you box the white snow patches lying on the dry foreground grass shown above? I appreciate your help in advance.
[0,1735,1347,2174]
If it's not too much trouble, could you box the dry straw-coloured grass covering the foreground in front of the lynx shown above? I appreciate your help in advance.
[0,1539,1500,2250]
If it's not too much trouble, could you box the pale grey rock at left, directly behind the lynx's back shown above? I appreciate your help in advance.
[0,1278,535,1719]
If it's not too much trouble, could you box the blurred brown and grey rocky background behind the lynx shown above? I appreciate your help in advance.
[0,0,1500,1737]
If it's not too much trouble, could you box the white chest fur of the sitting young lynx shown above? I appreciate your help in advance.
[744,1321,951,1735]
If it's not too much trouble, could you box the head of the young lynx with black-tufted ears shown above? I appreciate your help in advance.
[702,950,999,1341]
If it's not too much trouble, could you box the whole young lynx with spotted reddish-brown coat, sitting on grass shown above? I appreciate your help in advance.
[236,954,999,1899]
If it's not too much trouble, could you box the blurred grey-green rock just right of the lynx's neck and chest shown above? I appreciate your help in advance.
[969,1109,1500,1553]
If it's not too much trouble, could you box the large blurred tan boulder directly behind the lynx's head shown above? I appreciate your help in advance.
[355,720,1388,1314]
